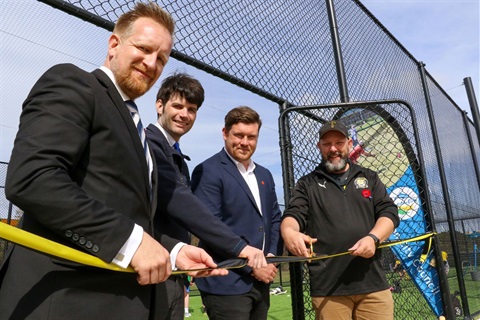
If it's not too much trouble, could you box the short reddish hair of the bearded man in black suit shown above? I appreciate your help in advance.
[113,2,175,37]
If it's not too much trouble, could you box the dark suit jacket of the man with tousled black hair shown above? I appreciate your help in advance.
[146,125,247,258]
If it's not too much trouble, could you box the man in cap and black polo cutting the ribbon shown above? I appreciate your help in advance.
[281,121,399,320]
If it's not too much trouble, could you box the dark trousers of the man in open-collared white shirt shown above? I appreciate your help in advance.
[200,281,270,320]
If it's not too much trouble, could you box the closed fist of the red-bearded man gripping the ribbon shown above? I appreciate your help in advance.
[130,232,172,285]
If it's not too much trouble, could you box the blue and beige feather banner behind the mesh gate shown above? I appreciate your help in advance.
[342,109,443,316]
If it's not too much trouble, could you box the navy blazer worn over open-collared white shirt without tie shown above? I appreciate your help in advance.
[192,149,283,295]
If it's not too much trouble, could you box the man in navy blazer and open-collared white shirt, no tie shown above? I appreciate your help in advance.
[192,107,283,320]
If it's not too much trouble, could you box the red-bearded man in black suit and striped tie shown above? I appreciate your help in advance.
[0,2,227,320]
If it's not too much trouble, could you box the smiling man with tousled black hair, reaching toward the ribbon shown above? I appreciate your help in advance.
[147,73,270,320]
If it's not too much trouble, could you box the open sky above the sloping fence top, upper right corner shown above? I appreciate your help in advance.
[362,0,480,118]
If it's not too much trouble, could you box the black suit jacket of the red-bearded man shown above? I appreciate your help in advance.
[0,64,177,319]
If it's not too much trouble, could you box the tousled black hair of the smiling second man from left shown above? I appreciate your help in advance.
[157,73,205,109]
